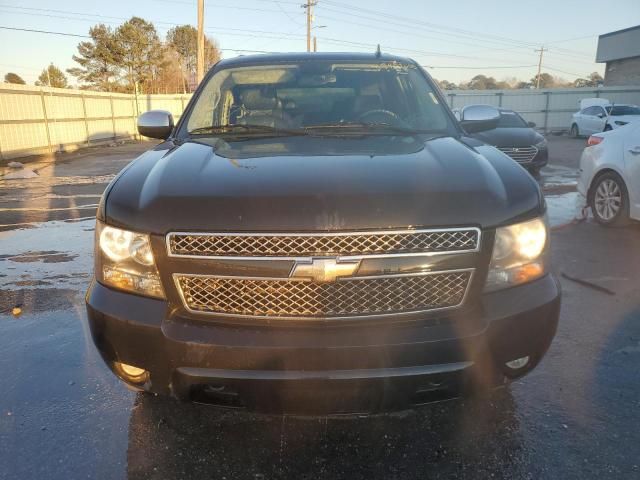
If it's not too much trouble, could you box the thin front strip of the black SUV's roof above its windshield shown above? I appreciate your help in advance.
[218,52,416,67]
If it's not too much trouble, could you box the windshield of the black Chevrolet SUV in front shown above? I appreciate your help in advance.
[186,61,455,134]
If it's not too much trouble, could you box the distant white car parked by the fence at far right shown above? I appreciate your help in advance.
[569,99,640,137]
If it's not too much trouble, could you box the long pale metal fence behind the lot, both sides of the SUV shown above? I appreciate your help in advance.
[0,83,640,159]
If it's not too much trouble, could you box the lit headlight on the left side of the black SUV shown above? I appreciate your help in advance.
[95,222,164,298]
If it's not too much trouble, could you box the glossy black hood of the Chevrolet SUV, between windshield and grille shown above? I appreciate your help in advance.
[105,136,544,234]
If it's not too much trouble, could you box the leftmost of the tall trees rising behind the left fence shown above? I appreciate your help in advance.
[67,24,123,92]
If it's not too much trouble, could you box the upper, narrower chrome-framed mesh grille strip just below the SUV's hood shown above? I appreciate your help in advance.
[167,228,480,257]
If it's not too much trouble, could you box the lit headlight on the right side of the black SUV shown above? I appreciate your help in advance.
[485,218,549,290]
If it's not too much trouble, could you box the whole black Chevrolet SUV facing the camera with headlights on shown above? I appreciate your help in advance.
[87,53,560,412]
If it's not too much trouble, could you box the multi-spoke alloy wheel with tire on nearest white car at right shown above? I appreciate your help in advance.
[589,172,629,227]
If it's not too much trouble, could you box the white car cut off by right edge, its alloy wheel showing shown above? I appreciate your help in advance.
[578,123,640,226]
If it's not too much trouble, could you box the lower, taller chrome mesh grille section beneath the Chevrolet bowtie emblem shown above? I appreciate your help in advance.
[175,270,471,318]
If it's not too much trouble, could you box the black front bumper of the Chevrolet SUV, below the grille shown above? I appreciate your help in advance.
[87,275,560,413]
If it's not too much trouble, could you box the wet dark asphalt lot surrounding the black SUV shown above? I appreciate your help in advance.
[0,137,640,479]
